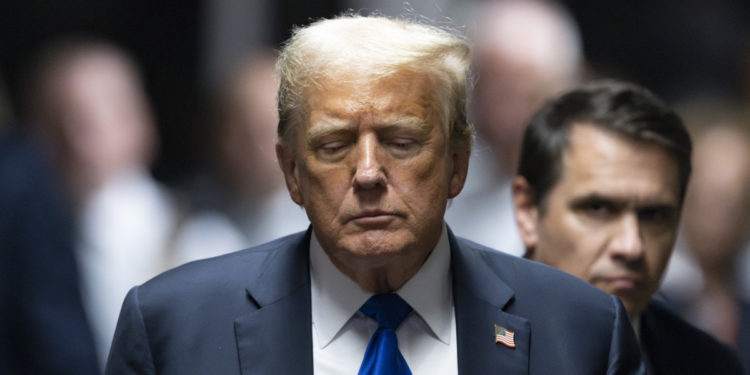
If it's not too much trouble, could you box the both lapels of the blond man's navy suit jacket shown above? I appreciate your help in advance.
[234,228,530,375]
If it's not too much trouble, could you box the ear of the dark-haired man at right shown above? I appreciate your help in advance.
[513,176,539,259]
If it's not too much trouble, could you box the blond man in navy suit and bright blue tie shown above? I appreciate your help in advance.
[107,16,642,374]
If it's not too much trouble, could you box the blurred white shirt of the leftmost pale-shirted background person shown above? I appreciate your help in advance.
[76,169,175,366]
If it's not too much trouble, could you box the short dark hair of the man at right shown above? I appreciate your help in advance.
[518,80,692,209]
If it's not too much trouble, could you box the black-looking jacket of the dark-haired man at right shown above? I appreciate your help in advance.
[641,301,743,375]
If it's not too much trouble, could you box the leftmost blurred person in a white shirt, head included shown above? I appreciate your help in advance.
[27,39,178,363]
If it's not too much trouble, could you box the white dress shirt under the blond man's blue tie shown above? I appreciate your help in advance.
[310,225,458,375]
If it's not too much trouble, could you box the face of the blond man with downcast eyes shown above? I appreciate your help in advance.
[279,72,469,280]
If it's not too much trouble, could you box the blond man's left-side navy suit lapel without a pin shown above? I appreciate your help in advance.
[234,229,313,375]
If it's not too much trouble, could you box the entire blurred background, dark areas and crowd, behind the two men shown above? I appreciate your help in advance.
[0,0,750,374]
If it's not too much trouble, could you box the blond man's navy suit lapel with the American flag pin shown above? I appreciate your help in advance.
[448,230,531,375]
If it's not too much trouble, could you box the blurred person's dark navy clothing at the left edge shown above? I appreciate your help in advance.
[0,73,99,375]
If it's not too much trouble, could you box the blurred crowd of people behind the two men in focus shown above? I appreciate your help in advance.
[0,1,750,374]
